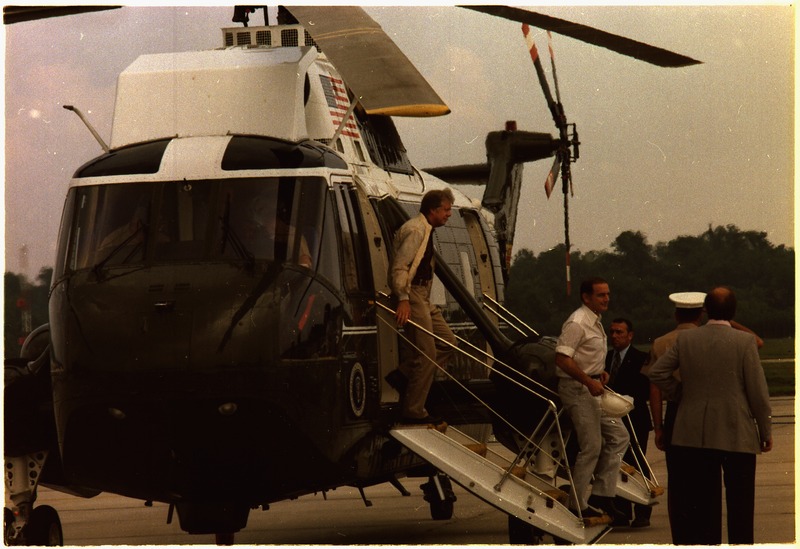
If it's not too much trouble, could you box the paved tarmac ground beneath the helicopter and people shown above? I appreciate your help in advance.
[32,398,797,546]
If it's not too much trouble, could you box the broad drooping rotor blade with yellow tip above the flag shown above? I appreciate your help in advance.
[286,6,450,116]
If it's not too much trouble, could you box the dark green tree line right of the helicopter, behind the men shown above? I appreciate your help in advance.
[506,225,795,343]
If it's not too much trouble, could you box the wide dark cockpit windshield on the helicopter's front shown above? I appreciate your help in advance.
[66,177,326,270]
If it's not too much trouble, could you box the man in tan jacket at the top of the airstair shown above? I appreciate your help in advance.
[386,189,456,424]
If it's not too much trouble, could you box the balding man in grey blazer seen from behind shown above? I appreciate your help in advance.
[649,287,772,545]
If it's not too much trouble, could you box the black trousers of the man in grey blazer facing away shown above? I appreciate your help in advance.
[668,445,756,545]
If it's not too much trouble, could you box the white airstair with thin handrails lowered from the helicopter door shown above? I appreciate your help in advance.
[378,296,664,545]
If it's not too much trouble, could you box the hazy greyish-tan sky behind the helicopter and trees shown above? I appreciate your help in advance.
[4,5,795,276]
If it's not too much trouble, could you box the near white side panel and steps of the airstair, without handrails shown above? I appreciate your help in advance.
[389,425,610,545]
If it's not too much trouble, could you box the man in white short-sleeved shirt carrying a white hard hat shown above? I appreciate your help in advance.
[556,278,629,523]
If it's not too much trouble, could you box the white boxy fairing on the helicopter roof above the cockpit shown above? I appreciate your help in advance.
[110,47,317,149]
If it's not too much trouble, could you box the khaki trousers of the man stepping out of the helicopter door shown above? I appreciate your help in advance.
[399,283,456,418]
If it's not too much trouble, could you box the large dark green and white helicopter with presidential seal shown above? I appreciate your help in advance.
[4,6,693,545]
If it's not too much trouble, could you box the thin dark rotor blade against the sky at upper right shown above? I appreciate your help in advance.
[462,6,702,67]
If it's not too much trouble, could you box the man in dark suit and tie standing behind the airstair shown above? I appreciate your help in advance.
[606,318,653,528]
